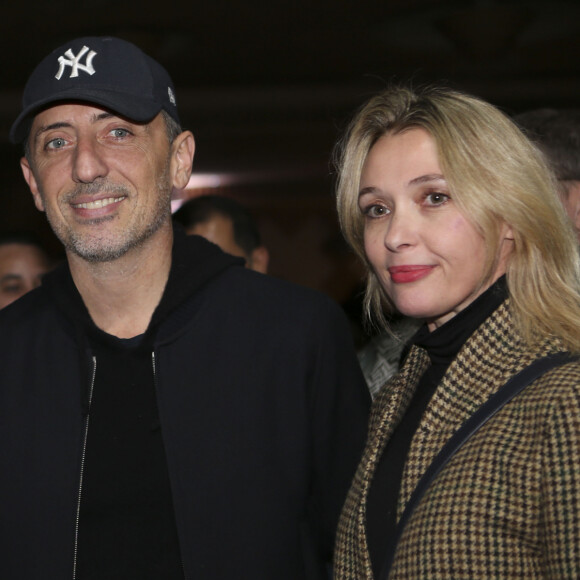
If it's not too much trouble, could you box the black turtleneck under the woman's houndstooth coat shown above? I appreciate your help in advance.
[366,276,507,578]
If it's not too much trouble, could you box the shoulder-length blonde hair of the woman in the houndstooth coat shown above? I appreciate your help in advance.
[335,87,580,352]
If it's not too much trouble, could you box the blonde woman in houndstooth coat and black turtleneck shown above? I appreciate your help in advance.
[335,88,580,580]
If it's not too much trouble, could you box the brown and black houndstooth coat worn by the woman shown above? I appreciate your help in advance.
[334,300,580,580]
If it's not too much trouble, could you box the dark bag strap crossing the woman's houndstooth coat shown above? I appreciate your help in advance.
[380,352,577,580]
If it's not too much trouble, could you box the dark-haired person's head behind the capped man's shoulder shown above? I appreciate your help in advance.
[173,195,269,274]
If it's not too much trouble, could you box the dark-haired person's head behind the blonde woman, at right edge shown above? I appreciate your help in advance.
[515,109,580,243]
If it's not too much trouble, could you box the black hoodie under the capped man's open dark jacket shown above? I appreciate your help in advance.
[68,233,243,580]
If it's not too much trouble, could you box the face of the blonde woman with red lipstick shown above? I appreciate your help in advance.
[359,128,513,330]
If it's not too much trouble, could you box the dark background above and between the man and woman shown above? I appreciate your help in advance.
[0,0,580,302]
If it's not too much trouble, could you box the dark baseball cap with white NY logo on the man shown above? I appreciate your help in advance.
[10,37,179,143]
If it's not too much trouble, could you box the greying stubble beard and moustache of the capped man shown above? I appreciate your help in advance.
[40,159,172,263]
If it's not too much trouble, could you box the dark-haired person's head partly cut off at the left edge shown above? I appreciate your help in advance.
[0,232,50,309]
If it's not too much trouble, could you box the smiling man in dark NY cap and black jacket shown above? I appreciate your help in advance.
[0,38,367,580]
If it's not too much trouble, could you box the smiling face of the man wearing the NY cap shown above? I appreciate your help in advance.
[22,104,173,262]
